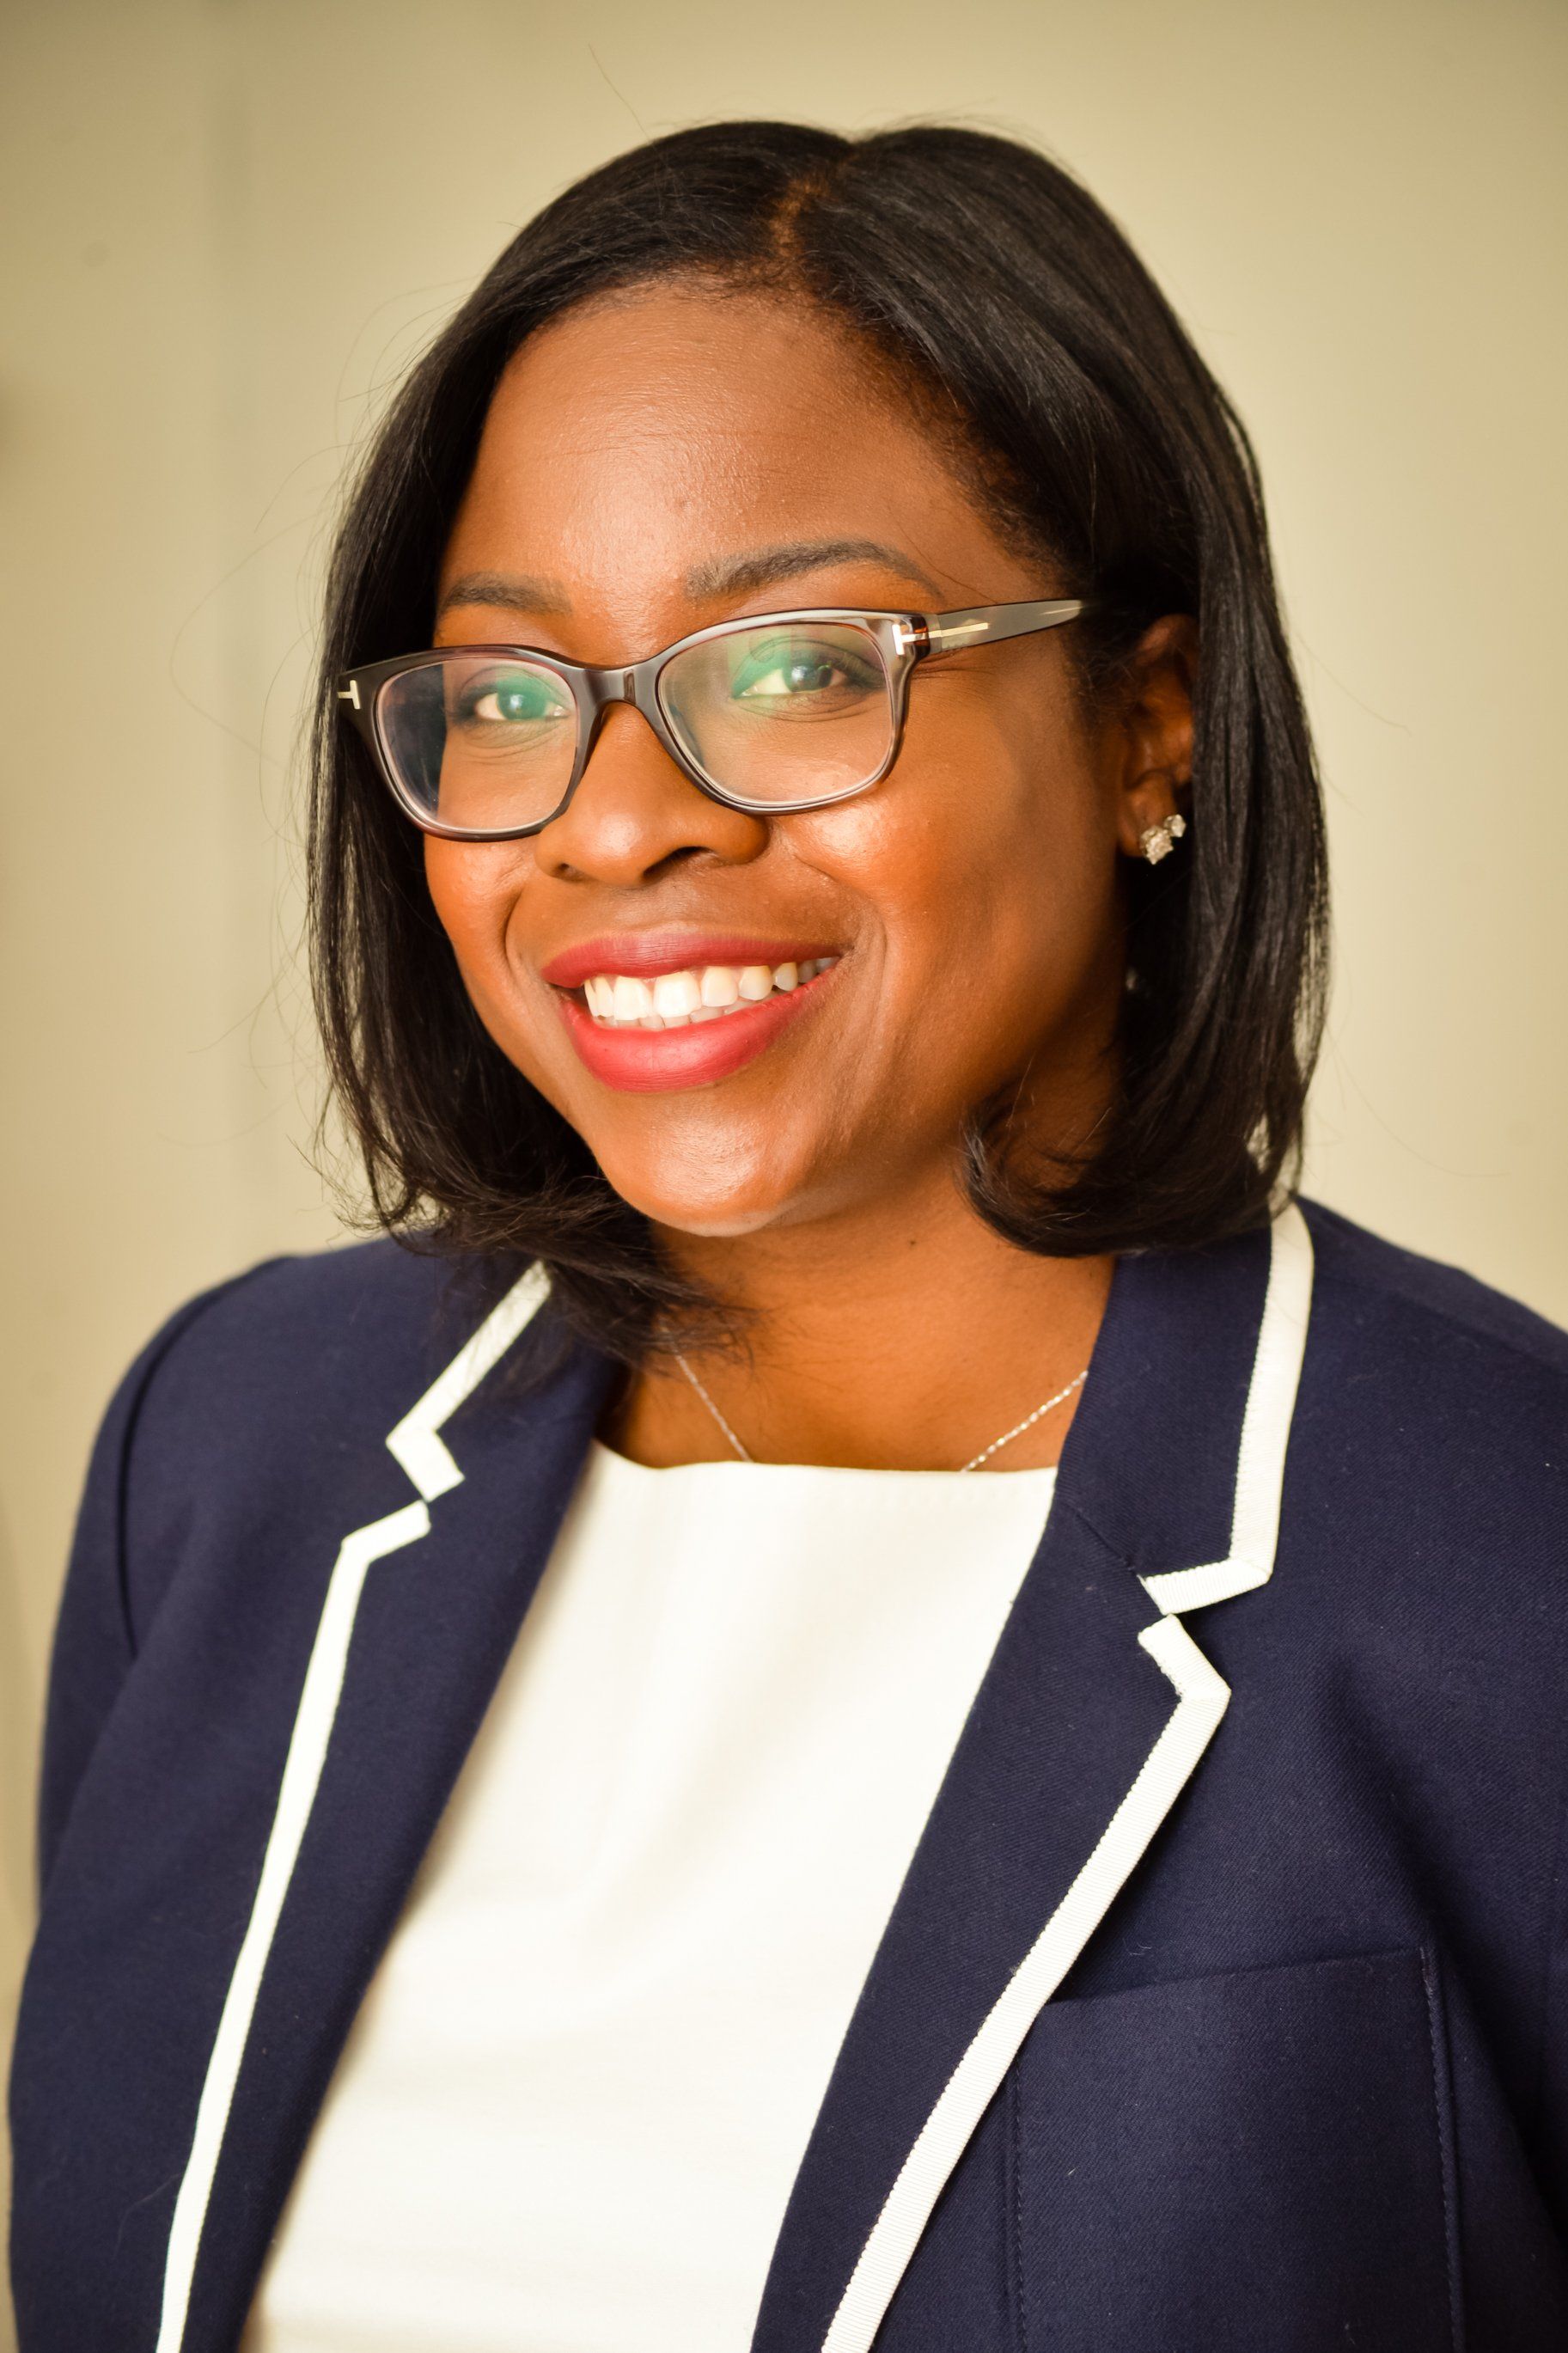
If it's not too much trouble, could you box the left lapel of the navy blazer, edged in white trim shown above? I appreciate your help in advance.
[157,1273,613,2353]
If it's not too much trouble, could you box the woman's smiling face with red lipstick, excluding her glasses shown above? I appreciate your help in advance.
[425,287,1168,1235]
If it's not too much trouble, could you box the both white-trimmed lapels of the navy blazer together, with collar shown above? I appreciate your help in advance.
[156,1209,1312,2353]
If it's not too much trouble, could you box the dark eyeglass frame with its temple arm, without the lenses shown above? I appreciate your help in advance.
[336,597,1086,842]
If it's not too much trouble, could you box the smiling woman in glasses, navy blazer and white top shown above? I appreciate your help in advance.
[14,125,1568,2353]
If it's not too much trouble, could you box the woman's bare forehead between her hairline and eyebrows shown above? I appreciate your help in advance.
[442,287,997,626]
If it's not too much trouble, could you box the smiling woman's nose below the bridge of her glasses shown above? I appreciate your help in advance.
[534,704,769,889]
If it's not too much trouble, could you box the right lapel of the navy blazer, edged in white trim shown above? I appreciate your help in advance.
[753,1209,1312,2353]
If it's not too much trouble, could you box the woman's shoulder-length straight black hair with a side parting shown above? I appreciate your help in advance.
[310,122,1326,1362]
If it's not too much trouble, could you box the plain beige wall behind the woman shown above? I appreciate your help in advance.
[0,0,1568,2315]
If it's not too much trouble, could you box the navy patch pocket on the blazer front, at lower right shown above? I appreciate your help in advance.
[1011,1953,1457,2353]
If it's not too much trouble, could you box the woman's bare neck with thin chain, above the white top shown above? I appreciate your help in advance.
[616,1170,1112,1470]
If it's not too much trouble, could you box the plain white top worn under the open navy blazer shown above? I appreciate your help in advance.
[242,1445,1056,2353]
